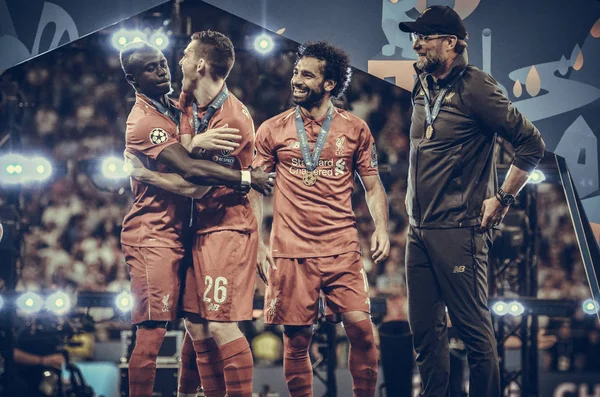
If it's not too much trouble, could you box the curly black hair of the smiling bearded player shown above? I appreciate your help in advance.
[296,41,352,98]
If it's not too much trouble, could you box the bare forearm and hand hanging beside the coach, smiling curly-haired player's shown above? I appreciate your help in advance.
[361,175,390,263]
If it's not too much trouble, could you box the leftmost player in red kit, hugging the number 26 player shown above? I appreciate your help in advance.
[120,43,272,397]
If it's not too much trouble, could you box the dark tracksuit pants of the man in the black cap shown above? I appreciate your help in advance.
[406,226,501,397]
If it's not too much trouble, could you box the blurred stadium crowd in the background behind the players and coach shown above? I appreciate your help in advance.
[0,4,600,370]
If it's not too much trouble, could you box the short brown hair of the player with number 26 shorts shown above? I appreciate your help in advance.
[192,30,235,80]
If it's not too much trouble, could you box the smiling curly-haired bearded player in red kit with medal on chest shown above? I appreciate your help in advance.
[254,42,390,397]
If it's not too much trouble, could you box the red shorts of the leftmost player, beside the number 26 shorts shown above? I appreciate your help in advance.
[123,245,183,324]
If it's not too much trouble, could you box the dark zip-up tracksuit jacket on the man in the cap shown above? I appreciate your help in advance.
[407,54,545,228]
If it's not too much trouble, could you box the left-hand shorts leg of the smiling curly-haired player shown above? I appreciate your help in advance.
[264,258,321,325]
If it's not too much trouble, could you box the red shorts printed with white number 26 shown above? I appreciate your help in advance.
[193,231,258,322]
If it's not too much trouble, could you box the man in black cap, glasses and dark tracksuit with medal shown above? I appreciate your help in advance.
[400,6,545,397]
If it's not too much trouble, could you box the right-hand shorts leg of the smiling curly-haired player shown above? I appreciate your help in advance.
[319,251,371,316]
